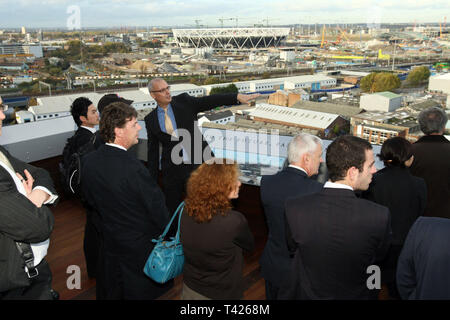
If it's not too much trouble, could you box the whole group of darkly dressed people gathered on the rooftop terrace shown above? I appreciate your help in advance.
[0,78,450,300]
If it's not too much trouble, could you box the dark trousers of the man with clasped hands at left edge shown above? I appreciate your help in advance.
[0,259,53,300]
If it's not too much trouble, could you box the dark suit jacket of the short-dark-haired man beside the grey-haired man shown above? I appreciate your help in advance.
[282,188,391,299]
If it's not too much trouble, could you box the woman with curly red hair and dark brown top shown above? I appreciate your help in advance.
[180,159,254,300]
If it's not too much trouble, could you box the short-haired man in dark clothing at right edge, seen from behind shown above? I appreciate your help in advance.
[411,107,450,218]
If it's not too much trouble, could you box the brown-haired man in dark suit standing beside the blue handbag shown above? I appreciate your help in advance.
[81,102,173,300]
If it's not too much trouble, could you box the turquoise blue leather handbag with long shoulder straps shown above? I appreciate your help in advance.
[144,202,184,283]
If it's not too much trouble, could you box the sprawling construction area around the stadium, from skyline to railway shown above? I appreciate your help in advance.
[0,17,450,94]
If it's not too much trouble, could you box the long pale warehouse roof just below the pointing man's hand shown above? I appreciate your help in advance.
[250,103,339,129]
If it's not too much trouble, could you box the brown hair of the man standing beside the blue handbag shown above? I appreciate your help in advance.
[100,102,137,142]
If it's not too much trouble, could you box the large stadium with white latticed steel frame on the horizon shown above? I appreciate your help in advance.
[172,28,290,49]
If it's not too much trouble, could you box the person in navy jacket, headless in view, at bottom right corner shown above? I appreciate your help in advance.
[397,217,450,300]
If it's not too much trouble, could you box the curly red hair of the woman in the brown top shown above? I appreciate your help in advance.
[185,159,240,223]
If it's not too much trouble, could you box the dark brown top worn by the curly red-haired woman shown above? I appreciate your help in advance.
[180,210,254,299]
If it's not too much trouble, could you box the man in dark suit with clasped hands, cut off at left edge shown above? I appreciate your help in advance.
[0,99,58,300]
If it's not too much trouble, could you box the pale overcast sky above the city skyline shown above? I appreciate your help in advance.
[0,0,450,29]
